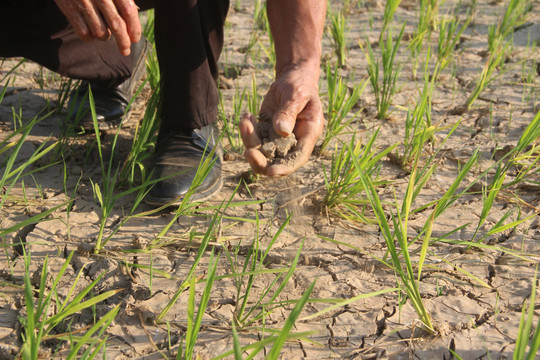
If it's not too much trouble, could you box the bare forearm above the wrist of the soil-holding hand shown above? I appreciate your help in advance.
[267,0,326,79]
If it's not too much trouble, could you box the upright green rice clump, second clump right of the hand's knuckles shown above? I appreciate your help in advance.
[360,25,405,119]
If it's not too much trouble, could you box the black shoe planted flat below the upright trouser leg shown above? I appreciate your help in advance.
[145,125,222,206]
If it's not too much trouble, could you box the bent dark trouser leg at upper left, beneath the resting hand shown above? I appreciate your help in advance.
[0,0,150,87]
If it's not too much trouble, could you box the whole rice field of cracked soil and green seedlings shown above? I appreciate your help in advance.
[0,0,540,360]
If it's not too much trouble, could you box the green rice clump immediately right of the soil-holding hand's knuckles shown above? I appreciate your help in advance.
[320,64,368,151]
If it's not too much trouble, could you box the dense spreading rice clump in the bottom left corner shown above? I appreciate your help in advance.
[19,248,121,360]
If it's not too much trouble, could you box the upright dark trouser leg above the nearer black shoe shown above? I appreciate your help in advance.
[155,0,229,135]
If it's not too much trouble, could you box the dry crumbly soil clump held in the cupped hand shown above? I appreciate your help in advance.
[257,121,297,164]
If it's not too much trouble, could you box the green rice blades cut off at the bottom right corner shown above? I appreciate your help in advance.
[513,266,540,360]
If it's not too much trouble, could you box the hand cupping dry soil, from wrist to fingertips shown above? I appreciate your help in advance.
[239,68,324,176]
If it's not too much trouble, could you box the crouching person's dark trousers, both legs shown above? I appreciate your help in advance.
[0,0,229,131]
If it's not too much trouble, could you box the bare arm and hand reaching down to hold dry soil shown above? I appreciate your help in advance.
[240,0,326,176]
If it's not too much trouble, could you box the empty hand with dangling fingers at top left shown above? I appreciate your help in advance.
[55,0,142,56]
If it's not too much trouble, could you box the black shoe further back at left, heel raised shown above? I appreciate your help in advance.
[68,38,149,130]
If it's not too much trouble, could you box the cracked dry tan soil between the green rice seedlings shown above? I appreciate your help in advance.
[0,0,540,359]
